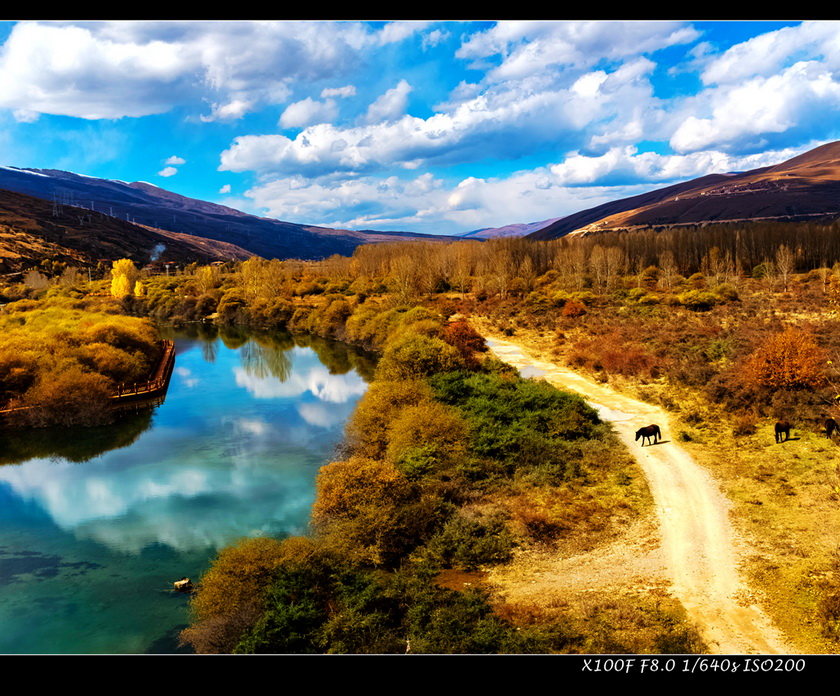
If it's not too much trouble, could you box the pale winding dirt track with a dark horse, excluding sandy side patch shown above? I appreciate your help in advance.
[487,338,795,655]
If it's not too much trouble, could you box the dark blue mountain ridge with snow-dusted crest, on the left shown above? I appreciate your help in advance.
[0,167,462,266]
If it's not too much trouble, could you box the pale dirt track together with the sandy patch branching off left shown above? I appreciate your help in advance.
[488,338,796,654]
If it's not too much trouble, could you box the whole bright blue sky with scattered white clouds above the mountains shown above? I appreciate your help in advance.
[0,20,840,234]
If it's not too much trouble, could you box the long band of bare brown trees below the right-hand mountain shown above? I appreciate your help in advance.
[217,223,840,302]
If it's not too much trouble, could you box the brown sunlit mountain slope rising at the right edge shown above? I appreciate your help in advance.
[528,142,840,240]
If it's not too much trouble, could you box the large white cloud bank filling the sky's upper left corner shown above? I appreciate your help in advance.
[0,21,378,120]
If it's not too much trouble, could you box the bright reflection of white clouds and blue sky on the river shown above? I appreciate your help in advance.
[0,334,366,553]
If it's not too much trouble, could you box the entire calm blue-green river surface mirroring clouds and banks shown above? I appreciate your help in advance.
[0,328,372,654]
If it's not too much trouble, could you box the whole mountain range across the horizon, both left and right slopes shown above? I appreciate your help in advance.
[0,142,840,273]
